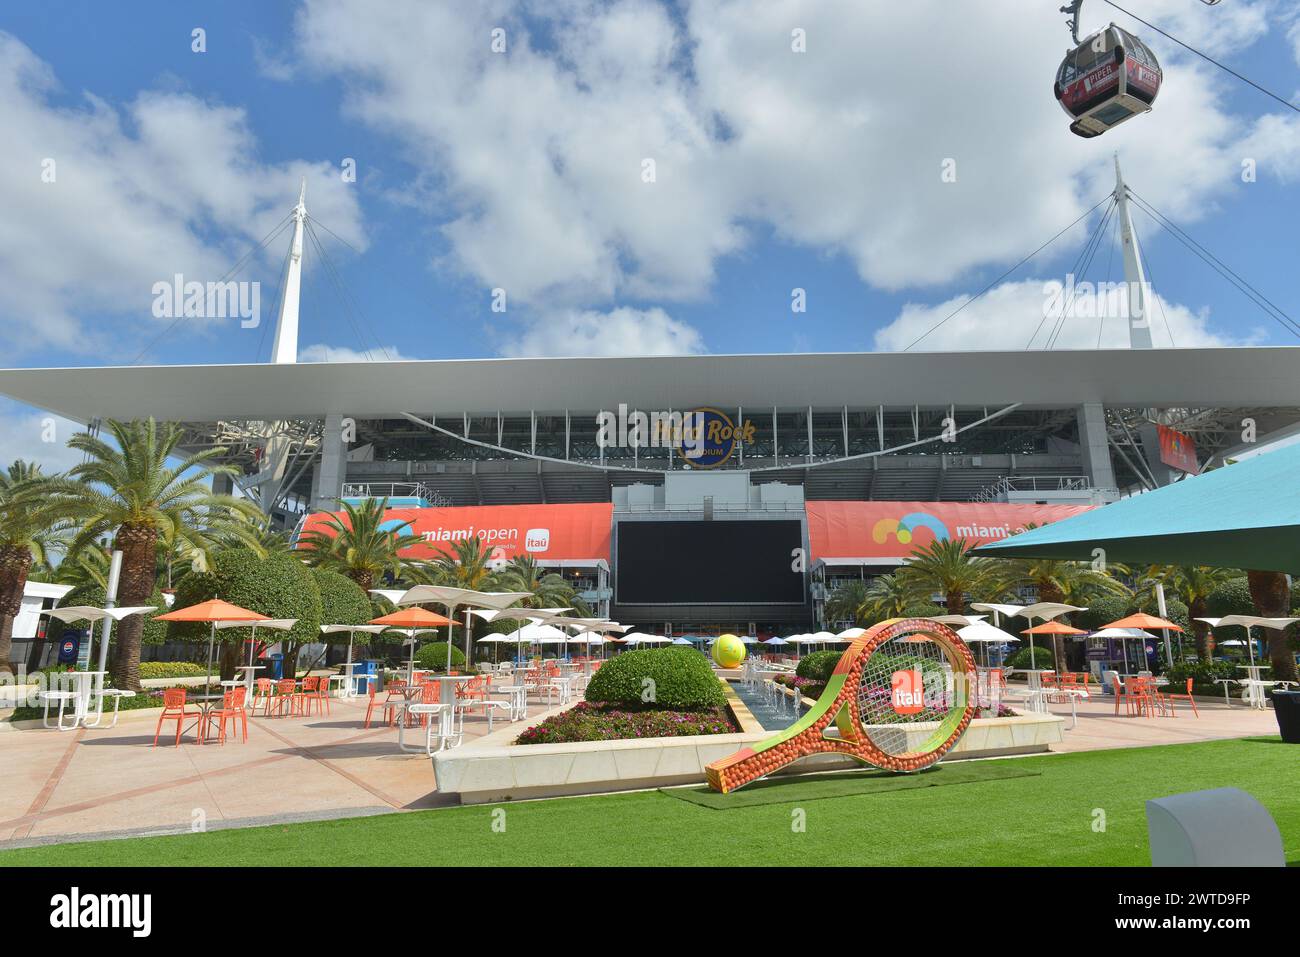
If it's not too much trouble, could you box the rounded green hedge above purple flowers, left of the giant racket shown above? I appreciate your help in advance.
[586,645,727,711]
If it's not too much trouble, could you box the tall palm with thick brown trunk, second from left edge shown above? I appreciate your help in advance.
[51,419,261,690]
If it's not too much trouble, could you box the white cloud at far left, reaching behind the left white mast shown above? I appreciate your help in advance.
[0,33,365,364]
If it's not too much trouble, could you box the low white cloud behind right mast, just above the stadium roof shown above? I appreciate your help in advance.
[875,280,1249,352]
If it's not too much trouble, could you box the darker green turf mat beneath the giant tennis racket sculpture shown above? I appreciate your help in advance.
[660,761,1039,811]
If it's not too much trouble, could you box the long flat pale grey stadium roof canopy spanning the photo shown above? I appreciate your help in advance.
[0,347,1300,423]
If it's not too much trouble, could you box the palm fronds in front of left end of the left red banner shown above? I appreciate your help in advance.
[298,498,411,593]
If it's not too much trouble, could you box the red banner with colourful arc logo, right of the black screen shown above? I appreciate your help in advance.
[807,502,1089,560]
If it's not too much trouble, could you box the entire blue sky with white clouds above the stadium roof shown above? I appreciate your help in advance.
[0,0,1300,468]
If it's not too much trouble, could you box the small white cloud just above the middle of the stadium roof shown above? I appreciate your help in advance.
[501,307,706,356]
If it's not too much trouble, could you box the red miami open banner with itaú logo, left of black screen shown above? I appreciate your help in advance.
[303,502,614,562]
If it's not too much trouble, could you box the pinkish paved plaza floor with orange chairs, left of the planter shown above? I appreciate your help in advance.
[0,698,560,848]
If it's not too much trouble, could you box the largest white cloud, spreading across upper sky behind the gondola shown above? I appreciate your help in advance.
[295,0,1295,309]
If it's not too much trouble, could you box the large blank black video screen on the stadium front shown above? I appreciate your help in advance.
[614,520,805,605]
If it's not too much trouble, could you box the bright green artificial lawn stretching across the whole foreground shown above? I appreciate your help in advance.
[0,739,1300,867]
